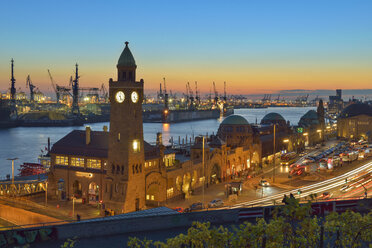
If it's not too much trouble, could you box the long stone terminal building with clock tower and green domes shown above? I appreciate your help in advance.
[48,42,303,214]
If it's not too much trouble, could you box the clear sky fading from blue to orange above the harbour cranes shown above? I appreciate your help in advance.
[0,0,372,93]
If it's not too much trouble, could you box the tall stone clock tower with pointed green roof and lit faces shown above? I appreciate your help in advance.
[104,42,145,214]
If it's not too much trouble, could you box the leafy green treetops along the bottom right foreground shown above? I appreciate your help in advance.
[127,196,372,248]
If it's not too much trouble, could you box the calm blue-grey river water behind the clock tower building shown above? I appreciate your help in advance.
[0,107,315,174]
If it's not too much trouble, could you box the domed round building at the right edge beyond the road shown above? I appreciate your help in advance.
[337,103,372,142]
